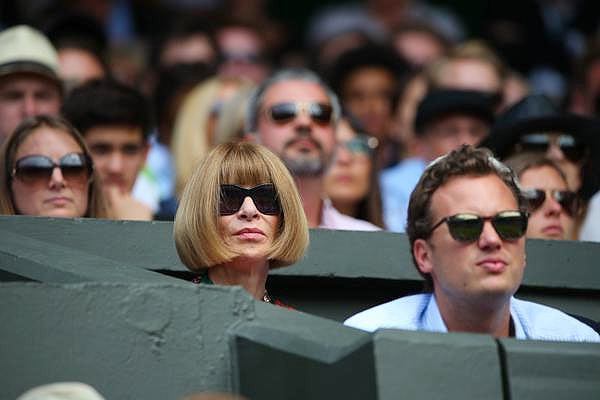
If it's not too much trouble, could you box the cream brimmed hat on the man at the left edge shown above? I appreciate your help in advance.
[0,25,60,84]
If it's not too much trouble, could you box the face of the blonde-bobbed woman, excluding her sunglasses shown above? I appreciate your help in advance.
[219,186,280,260]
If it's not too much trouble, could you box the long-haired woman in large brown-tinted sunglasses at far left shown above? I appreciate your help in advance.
[0,115,107,218]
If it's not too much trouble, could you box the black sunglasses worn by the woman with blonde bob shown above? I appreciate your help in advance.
[219,183,281,215]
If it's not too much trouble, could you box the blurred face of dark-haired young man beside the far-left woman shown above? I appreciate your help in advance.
[84,125,149,194]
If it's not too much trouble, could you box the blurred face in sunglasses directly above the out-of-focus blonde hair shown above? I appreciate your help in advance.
[217,26,269,83]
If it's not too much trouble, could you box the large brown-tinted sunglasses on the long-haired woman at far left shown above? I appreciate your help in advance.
[12,153,93,184]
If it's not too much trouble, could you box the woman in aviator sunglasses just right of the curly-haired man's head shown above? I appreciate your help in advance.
[505,153,580,240]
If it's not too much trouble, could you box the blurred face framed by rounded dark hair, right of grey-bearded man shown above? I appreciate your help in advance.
[342,67,398,139]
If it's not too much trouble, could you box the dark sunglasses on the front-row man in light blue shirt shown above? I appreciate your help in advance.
[429,210,528,243]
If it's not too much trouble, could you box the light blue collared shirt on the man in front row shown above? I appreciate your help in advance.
[344,293,600,342]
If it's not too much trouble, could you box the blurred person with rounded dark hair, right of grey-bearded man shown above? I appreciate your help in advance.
[331,45,408,168]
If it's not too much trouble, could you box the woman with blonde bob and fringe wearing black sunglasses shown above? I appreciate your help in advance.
[174,142,309,302]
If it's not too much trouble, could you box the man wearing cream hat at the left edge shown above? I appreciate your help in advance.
[0,25,62,143]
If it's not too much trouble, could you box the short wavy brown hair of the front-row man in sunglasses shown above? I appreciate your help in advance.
[406,145,525,288]
